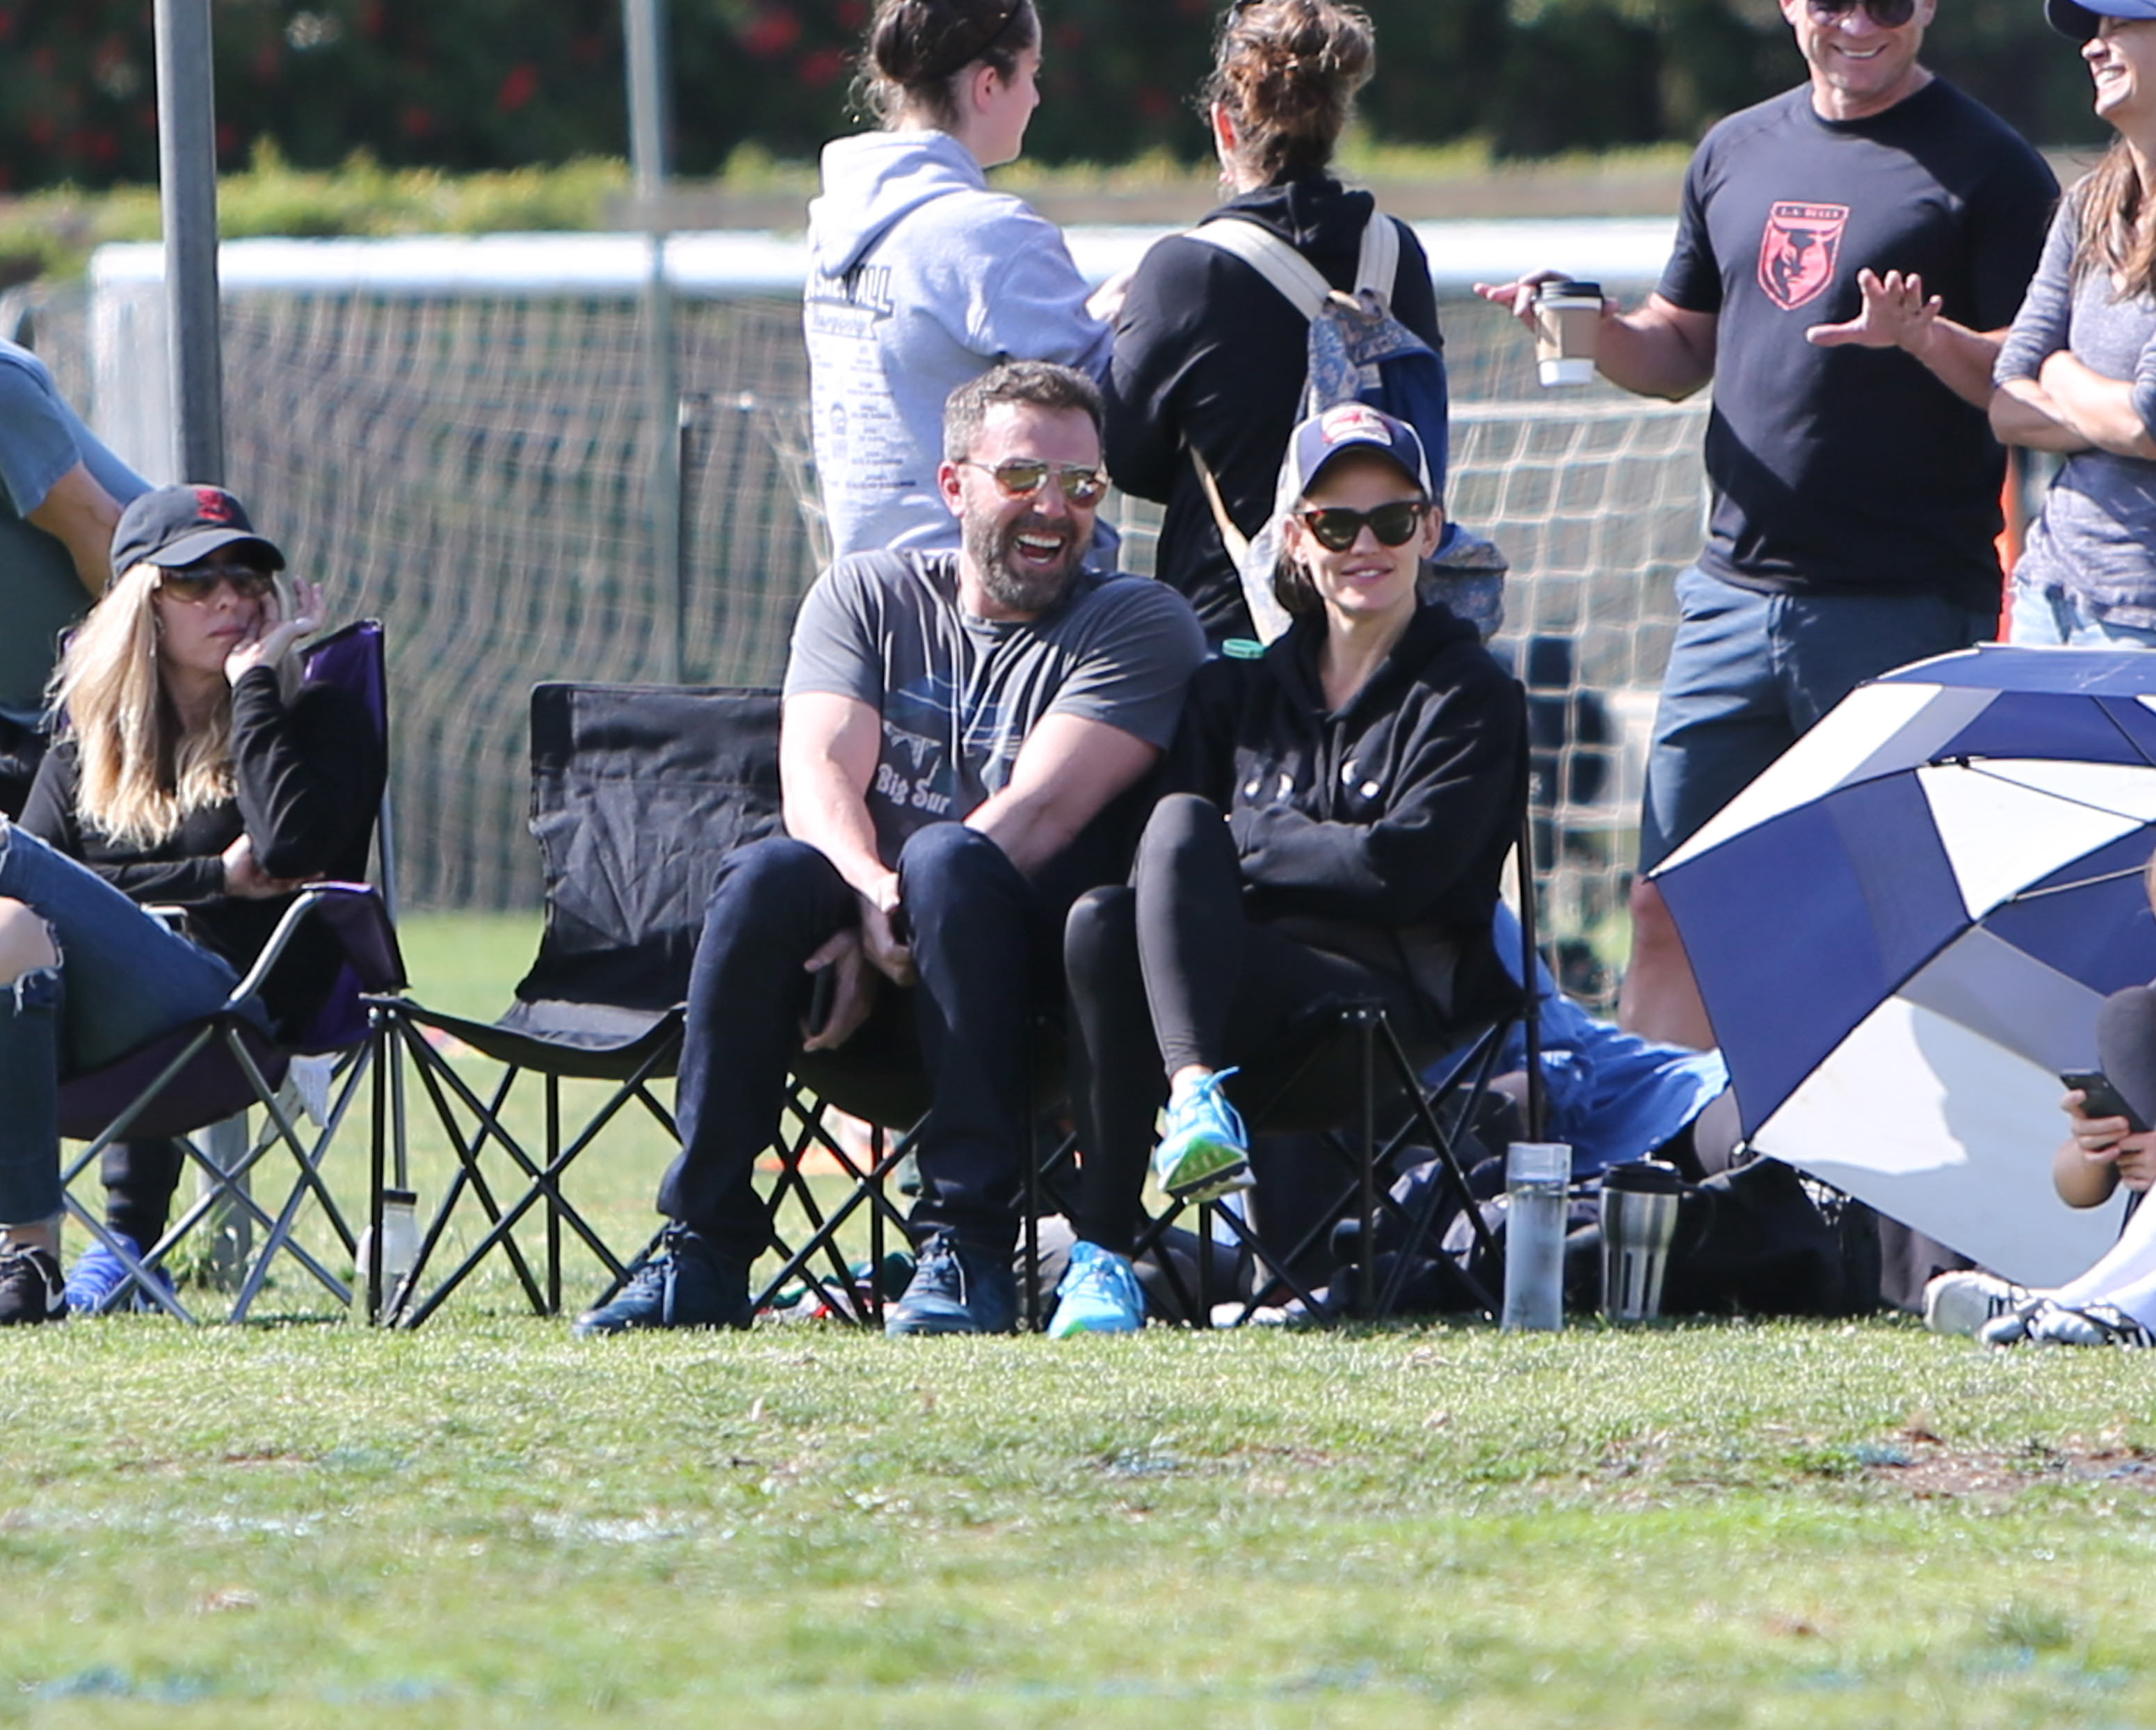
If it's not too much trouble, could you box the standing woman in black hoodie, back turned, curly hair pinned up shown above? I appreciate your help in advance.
[1106,0,1442,642]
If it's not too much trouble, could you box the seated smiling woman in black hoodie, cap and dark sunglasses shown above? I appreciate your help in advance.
[1050,403,1527,1336]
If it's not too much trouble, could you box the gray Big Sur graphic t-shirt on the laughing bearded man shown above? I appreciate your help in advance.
[785,551,1205,864]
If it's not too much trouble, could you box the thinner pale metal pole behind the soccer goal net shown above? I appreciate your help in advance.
[621,0,688,685]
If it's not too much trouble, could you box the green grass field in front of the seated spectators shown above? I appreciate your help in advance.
[17,920,2156,1730]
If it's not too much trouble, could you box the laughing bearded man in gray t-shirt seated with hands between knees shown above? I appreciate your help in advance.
[578,362,1205,1334]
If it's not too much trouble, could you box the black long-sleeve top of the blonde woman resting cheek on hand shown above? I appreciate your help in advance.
[22,668,386,1030]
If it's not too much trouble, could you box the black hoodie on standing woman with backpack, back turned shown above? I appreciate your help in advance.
[1106,175,1440,642]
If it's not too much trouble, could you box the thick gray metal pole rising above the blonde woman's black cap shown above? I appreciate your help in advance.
[157,0,224,487]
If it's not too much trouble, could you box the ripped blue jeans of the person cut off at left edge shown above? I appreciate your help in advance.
[0,823,239,1226]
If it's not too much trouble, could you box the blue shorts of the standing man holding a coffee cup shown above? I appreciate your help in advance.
[1639,565,1997,873]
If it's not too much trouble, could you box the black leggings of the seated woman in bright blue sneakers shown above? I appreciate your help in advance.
[1063,793,1429,1256]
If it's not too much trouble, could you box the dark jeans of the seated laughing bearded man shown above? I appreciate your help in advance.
[658,823,1061,1261]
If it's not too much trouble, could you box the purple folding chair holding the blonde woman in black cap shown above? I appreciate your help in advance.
[61,618,405,1323]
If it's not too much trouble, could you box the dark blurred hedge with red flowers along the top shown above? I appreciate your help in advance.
[0,0,2100,192]
